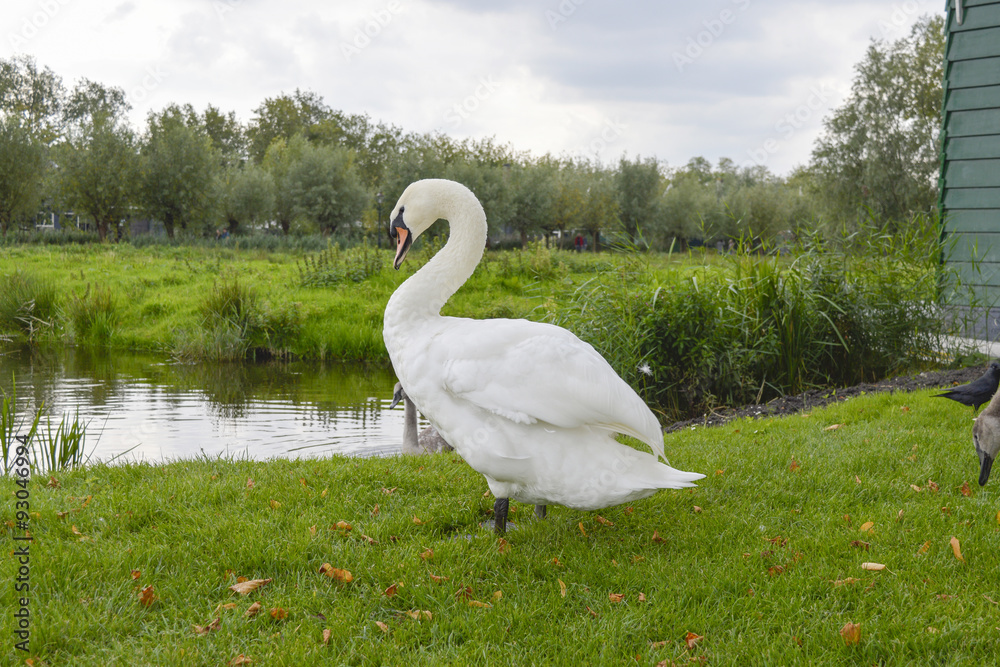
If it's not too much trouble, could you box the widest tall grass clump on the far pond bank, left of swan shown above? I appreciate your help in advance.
[173,275,302,361]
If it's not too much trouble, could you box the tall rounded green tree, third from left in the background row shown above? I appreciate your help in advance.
[141,107,220,238]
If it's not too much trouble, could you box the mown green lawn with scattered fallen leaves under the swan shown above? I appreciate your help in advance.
[0,392,1000,666]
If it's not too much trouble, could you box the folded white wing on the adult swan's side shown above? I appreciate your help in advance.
[443,320,663,456]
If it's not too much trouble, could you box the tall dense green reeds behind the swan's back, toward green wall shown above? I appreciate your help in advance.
[563,217,972,418]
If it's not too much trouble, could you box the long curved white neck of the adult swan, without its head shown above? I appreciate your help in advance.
[385,192,486,329]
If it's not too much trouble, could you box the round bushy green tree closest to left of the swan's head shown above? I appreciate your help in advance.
[287,142,369,234]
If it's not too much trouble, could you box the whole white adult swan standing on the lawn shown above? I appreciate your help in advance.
[383,179,704,533]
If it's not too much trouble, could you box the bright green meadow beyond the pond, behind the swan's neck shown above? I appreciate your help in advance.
[0,244,624,361]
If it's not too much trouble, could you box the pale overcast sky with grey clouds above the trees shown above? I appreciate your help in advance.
[0,0,944,174]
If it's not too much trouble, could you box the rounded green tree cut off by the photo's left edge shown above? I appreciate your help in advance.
[0,115,46,237]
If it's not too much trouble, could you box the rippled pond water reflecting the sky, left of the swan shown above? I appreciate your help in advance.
[0,349,414,462]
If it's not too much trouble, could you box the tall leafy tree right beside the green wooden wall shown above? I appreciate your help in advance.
[812,16,944,226]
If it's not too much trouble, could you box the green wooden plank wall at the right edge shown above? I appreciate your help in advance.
[940,0,1000,318]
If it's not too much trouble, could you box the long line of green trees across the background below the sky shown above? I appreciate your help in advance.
[0,17,944,250]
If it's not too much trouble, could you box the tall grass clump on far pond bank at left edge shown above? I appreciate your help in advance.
[0,271,58,343]
